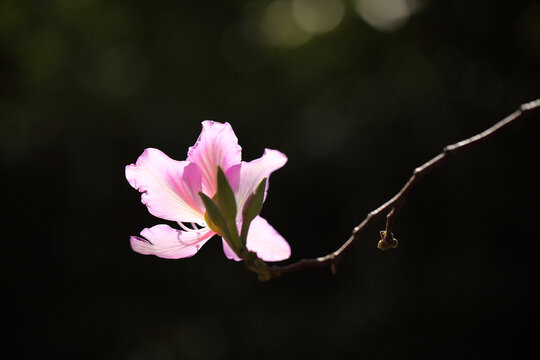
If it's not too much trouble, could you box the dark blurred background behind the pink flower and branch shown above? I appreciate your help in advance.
[0,0,540,360]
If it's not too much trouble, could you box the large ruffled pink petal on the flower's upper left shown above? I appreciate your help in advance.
[126,148,204,223]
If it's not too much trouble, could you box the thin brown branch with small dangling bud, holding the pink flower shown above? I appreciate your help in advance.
[267,99,540,278]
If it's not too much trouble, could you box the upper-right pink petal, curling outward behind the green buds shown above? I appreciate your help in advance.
[227,149,287,214]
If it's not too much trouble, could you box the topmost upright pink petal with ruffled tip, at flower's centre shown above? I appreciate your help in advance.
[187,121,242,197]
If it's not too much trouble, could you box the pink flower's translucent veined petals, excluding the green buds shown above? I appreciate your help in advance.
[126,121,291,261]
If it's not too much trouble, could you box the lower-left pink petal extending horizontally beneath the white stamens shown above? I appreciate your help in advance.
[130,225,215,259]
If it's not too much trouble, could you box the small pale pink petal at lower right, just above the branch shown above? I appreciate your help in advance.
[246,216,291,261]
